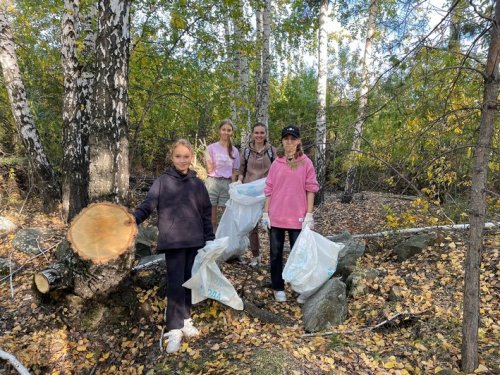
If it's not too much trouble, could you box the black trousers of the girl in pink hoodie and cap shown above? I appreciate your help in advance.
[269,227,301,290]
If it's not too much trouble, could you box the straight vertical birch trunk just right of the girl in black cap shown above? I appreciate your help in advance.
[315,0,328,203]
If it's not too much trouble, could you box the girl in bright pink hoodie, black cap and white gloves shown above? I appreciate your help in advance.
[261,125,319,302]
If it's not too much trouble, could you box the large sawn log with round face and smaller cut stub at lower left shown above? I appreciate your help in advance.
[34,202,137,298]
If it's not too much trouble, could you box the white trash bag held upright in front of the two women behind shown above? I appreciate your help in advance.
[215,178,266,261]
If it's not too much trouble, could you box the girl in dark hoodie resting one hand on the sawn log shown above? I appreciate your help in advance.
[134,139,215,353]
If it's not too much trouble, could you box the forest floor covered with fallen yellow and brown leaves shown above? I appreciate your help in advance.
[0,193,500,375]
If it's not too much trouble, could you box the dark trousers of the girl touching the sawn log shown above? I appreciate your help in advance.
[165,248,198,331]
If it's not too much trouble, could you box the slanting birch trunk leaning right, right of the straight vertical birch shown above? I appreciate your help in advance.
[341,0,378,203]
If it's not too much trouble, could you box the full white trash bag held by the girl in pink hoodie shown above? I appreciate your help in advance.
[282,226,345,296]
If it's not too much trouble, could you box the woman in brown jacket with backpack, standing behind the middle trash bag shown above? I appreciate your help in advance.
[238,122,276,267]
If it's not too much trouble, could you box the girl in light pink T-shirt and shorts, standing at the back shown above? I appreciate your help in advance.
[205,119,240,231]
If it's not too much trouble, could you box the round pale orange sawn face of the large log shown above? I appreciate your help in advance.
[67,202,137,264]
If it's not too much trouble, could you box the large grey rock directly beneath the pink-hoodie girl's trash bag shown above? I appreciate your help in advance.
[302,278,347,332]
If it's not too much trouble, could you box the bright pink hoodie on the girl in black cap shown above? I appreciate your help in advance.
[264,155,319,229]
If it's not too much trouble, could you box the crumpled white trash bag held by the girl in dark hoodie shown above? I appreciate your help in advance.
[182,237,243,310]
